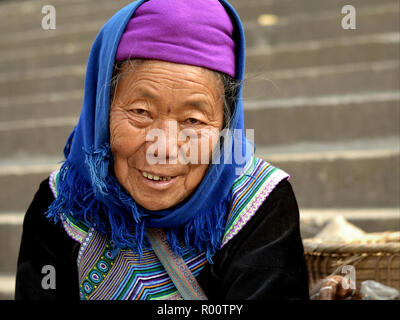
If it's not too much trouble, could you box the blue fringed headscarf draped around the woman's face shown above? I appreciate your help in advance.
[47,0,251,261]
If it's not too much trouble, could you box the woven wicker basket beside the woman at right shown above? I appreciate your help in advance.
[303,232,400,290]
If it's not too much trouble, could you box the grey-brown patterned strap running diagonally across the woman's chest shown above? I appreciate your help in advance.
[146,229,207,300]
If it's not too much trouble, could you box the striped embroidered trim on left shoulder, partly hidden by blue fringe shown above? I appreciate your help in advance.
[49,171,89,243]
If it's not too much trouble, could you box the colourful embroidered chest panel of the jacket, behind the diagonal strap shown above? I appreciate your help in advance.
[78,231,207,300]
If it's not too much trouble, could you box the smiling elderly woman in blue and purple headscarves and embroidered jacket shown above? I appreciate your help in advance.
[16,0,308,300]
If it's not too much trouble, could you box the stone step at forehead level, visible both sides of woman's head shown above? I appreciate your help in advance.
[0,56,400,100]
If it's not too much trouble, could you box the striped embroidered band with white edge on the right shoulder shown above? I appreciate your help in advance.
[221,158,290,248]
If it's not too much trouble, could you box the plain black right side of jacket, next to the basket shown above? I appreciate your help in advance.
[201,175,308,300]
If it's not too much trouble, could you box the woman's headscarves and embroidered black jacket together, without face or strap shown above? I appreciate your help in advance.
[16,0,308,300]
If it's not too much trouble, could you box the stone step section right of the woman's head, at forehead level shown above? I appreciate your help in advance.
[243,60,400,100]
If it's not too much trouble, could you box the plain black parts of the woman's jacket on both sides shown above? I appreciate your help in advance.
[15,179,308,300]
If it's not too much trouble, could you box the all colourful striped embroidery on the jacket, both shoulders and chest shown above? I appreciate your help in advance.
[49,158,289,300]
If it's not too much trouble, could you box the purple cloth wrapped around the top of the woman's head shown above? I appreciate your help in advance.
[116,0,235,77]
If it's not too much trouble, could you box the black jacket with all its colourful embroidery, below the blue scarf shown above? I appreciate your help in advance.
[16,158,308,299]
